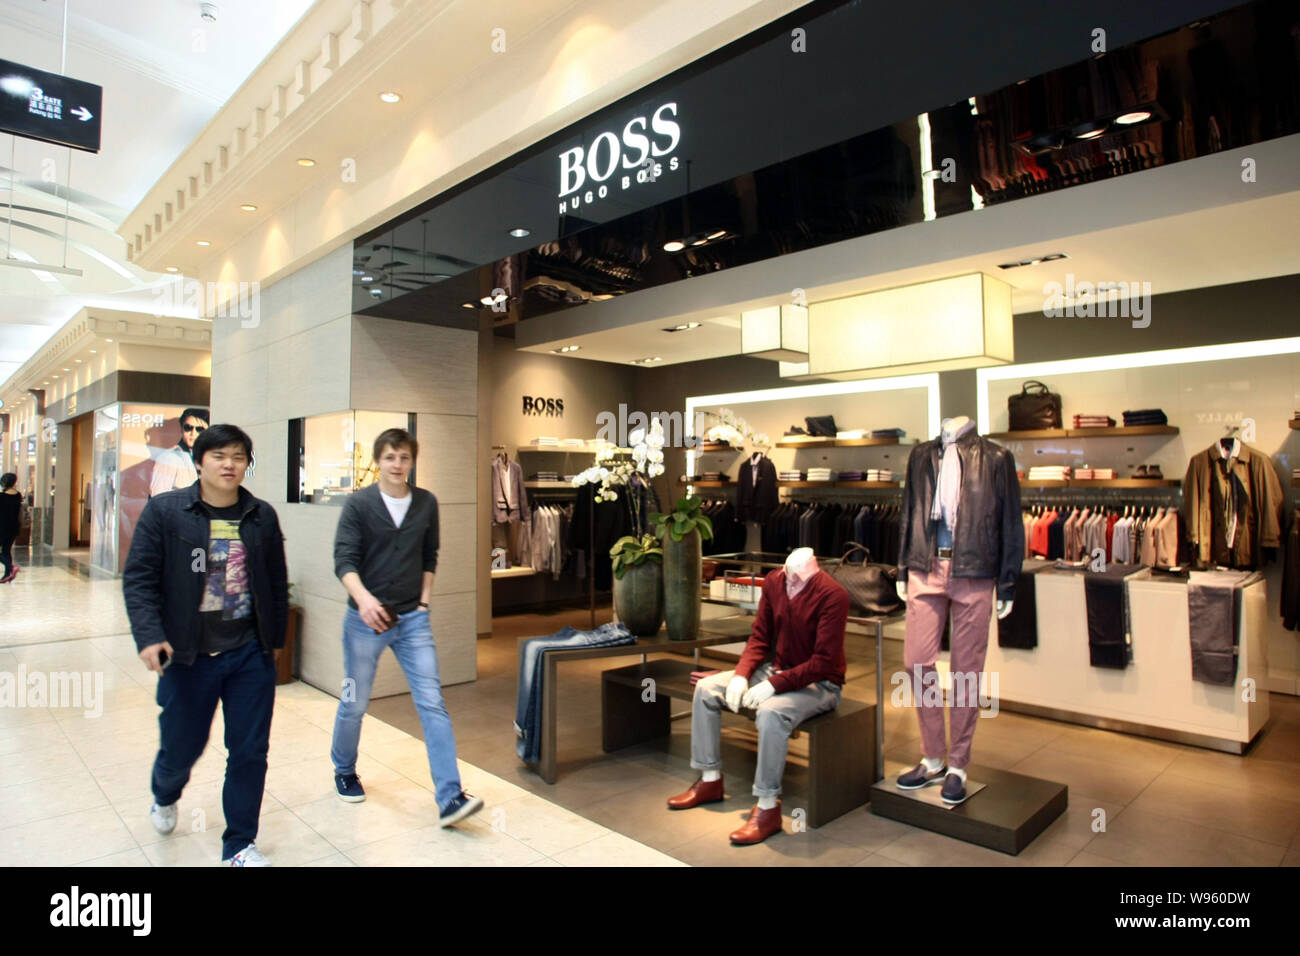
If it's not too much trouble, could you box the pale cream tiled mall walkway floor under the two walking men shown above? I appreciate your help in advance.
[0,555,680,866]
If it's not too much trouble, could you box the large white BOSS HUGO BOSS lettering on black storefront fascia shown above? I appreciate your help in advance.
[559,103,681,213]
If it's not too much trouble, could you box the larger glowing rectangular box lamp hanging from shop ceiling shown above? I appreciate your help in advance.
[807,273,1015,381]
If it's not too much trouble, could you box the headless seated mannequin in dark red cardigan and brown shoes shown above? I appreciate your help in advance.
[668,548,849,845]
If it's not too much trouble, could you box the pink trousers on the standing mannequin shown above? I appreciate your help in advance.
[904,558,996,770]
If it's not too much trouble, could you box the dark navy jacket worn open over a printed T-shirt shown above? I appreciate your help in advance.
[122,481,289,665]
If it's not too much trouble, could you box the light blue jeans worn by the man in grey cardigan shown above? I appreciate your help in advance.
[330,607,460,808]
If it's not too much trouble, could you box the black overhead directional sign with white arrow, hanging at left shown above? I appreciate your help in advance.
[0,60,104,152]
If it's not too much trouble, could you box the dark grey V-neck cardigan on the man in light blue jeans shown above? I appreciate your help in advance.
[334,484,438,614]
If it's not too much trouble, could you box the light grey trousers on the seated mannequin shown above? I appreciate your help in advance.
[690,663,842,797]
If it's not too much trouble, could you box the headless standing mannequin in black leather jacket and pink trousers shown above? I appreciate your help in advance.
[897,415,1024,805]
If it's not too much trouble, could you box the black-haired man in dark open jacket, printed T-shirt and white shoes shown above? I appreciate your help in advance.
[122,425,289,866]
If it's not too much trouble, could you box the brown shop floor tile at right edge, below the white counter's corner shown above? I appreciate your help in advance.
[1128,774,1300,847]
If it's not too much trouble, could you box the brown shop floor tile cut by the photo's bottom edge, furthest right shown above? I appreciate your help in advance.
[1084,808,1287,866]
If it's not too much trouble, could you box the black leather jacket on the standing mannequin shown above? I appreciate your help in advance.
[898,431,1024,601]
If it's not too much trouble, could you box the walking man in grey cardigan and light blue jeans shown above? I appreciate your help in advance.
[330,428,484,827]
